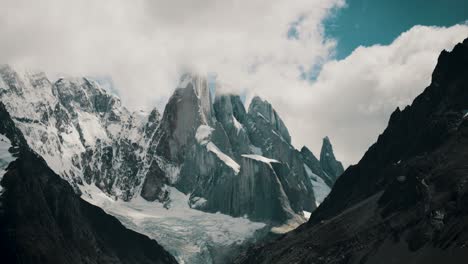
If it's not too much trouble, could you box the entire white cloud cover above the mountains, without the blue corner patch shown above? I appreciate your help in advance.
[0,0,468,165]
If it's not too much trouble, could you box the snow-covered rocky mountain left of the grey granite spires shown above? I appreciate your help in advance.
[0,66,159,200]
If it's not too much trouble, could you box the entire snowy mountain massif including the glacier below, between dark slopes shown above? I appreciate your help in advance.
[0,65,344,263]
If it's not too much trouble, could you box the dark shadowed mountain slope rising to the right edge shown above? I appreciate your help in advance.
[235,39,468,264]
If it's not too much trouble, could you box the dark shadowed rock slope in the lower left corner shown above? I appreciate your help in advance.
[0,103,177,264]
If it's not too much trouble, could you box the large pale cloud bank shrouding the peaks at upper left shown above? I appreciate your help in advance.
[0,0,344,108]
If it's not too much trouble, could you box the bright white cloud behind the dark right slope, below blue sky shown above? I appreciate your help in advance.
[265,25,468,165]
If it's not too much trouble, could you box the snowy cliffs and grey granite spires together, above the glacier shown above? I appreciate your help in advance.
[0,66,342,223]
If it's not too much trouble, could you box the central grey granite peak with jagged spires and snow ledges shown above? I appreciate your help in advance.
[151,76,344,223]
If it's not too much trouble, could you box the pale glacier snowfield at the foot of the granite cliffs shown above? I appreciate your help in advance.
[82,185,265,264]
